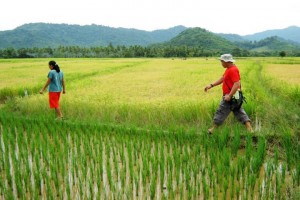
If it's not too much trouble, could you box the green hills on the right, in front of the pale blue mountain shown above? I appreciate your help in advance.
[166,28,300,52]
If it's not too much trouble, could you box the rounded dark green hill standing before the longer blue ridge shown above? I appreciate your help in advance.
[163,28,237,51]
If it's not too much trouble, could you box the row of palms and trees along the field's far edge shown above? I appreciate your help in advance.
[0,44,300,58]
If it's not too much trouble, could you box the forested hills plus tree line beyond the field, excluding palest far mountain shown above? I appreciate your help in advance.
[0,23,300,58]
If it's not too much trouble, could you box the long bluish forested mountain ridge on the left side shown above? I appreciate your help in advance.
[0,23,186,49]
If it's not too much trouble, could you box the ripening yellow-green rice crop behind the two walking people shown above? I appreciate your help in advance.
[0,58,300,133]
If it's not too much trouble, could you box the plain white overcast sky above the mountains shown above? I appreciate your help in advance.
[0,0,300,35]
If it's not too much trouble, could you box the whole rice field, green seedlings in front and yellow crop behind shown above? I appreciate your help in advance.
[0,58,300,199]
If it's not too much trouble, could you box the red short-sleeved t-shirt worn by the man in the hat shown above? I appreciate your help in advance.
[222,65,240,95]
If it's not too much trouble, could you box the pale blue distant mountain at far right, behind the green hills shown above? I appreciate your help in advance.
[243,26,300,44]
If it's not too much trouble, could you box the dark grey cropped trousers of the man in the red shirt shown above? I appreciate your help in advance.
[214,99,251,125]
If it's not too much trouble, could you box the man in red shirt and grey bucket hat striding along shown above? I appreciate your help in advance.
[204,54,253,134]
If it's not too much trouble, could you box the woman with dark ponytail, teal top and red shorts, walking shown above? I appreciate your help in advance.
[40,60,66,120]
